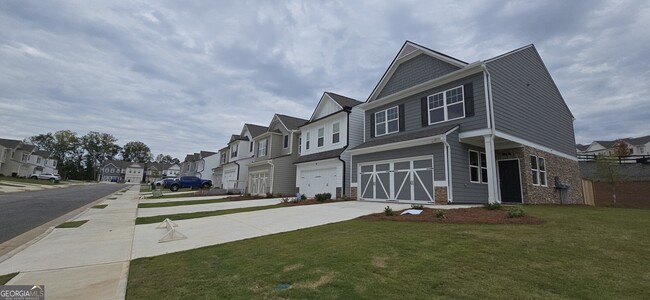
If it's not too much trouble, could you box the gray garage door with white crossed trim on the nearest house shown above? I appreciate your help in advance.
[359,157,434,202]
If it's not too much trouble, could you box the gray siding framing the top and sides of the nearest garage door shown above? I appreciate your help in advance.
[351,143,445,183]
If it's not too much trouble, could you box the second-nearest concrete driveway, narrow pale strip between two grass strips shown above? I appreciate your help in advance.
[138,198,282,217]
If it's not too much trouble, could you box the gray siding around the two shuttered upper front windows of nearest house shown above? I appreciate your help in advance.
[365,73,487,142]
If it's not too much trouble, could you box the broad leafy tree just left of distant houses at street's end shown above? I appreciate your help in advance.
[81,131,122,179]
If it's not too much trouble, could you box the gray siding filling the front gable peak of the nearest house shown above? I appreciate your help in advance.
[377,54,459,98]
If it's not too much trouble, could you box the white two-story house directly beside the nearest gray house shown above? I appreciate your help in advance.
[295,92,363,197]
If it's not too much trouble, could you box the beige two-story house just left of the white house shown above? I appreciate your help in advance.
[248,114,307,195]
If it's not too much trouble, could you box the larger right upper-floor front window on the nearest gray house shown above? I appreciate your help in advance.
[427,86,465,125]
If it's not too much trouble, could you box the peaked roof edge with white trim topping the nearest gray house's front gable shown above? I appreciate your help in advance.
[366,40,468,102]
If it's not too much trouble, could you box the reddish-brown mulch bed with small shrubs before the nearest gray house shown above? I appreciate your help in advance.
[360,207,544,224]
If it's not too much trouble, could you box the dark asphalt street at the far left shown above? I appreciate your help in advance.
[0,184,125,243]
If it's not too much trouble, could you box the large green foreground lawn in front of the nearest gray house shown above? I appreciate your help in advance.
[127,206,650,299]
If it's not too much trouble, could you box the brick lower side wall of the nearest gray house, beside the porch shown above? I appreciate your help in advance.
[496,146,584,204]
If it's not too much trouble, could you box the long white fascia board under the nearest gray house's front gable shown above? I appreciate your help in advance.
[358,61,483,110]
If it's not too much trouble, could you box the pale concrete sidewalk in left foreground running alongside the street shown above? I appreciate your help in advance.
[0,186,139,299]
